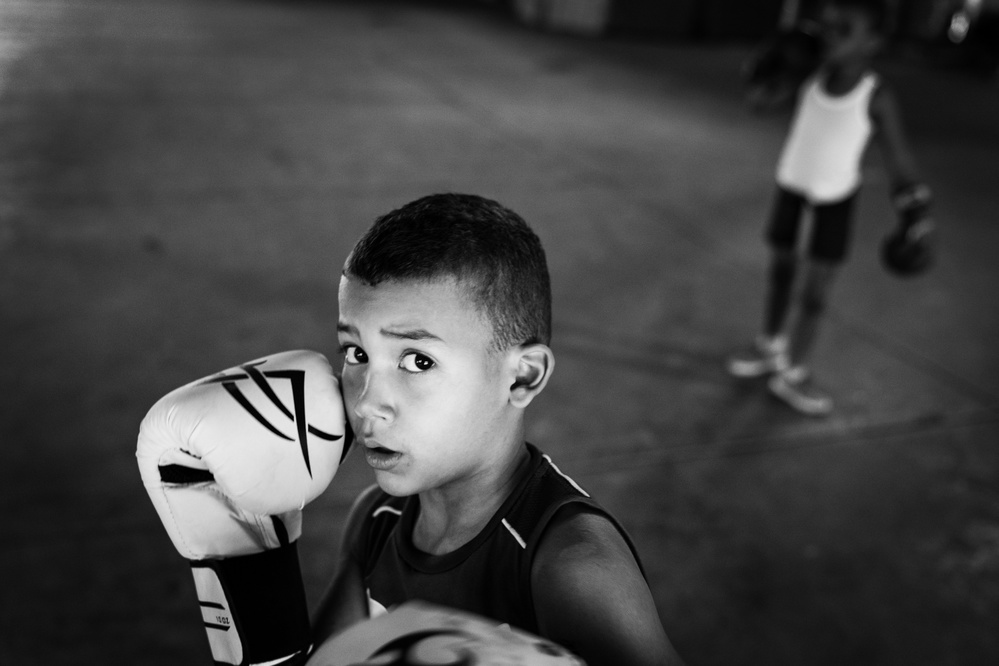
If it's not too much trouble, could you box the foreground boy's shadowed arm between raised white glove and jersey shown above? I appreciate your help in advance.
[312,486,378,646]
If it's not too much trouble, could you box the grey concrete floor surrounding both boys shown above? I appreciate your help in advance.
[0,0,999,666]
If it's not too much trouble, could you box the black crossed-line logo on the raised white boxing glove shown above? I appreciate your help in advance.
[203,361,343,476]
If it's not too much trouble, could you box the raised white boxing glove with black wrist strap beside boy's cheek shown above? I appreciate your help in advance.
[136,351,350,664]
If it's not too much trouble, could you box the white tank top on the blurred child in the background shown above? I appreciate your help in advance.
[777,73,878,204]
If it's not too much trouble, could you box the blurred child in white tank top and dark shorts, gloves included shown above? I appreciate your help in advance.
[728,0,934,416]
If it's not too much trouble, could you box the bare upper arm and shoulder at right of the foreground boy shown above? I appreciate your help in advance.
[531,504,683,666]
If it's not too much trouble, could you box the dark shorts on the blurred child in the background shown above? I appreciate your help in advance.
[767,187,857,263]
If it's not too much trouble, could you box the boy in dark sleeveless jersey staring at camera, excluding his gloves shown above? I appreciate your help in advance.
[314,194,679,666]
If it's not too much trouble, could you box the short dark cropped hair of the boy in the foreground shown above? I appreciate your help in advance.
[344,194,551,350]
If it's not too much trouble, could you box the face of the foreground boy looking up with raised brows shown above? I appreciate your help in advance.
[337,275,516,495]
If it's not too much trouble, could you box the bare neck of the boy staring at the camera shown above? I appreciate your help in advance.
[412,441,530,555]
